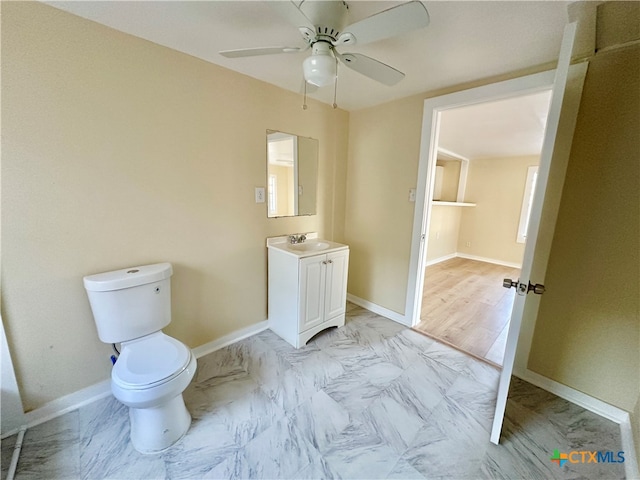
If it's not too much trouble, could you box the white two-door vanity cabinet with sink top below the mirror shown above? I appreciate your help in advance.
[268,237,349,348]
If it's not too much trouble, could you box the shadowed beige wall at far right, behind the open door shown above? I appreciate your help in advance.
[529,41,640,411]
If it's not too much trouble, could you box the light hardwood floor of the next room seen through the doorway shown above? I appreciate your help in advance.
[415,258,520,366]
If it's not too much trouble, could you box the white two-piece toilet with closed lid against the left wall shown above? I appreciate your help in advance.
[84,263,196,453]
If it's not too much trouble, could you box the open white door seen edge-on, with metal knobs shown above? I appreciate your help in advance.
[491,23,587,444]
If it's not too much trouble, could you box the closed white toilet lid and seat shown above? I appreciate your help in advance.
[111,331,191,390]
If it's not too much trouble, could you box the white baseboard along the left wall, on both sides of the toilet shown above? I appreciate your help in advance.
[2,320,267,438]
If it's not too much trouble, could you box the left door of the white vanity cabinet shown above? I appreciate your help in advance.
[298,255,327,332]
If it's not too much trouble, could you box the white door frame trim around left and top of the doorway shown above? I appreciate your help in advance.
[405,70,555,327]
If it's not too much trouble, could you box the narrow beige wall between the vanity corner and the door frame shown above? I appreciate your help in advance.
[345,97,423,313]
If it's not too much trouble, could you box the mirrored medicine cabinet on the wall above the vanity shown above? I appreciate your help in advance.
[266,130,318,218]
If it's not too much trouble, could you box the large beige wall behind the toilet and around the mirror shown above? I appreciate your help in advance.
[1,2,348,410]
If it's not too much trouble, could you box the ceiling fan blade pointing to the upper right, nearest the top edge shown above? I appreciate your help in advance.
[335,1,429,45]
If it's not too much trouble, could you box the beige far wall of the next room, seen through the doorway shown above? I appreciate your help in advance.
[458,156,540,265]
